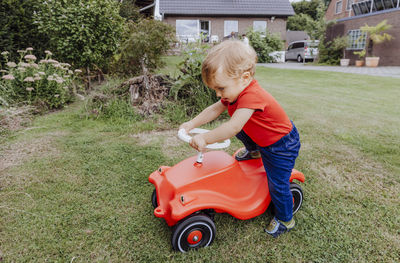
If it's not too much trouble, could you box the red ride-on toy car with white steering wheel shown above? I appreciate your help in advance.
[149,129,304,252]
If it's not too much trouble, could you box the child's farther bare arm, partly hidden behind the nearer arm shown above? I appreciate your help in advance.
[179,101,228,132]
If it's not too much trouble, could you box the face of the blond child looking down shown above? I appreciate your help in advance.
[210,70,251,103]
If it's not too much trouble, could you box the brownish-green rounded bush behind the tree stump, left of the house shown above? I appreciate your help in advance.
[112,19,176,76]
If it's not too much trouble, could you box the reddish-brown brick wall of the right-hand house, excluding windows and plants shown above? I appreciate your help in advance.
[326,9,400,66]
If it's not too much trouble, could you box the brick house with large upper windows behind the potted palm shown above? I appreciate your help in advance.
[325,0,400,66]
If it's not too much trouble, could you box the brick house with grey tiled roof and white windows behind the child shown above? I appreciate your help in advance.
[159,0,294,42]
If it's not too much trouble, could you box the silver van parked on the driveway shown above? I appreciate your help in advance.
[285,40,319,62]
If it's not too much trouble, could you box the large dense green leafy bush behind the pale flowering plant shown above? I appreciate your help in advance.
[35,0,124,69]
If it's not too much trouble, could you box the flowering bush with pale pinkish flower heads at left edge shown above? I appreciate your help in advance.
[0,48,79,110]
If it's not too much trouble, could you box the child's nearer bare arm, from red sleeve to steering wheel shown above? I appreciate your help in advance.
[190,108,254,151]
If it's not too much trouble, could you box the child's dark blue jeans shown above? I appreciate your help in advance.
[236,122,300,222]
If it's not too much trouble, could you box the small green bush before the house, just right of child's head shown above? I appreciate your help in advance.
[248,30,283,63]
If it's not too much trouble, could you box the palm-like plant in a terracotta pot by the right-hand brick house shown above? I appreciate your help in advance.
[360,20,392,67]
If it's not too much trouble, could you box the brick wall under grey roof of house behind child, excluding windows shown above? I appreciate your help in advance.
[163,16,286,41]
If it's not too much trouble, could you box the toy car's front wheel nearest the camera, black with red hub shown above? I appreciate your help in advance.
[171,214,215,252]
